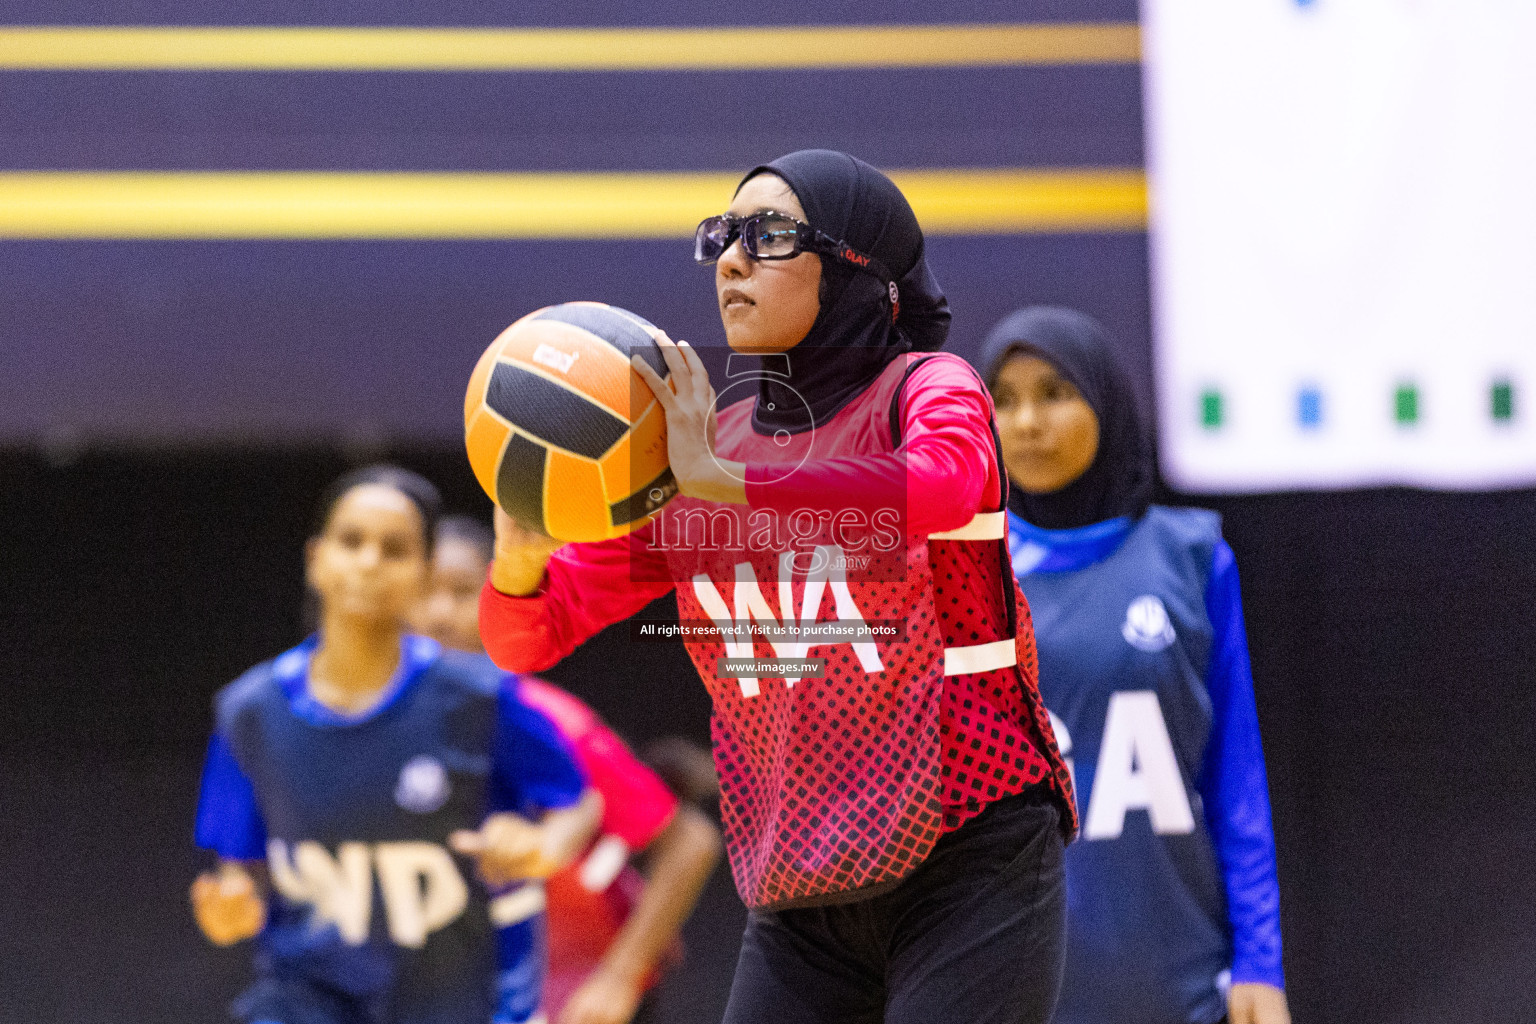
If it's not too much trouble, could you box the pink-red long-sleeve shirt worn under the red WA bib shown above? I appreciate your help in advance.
[481,358,1054,829]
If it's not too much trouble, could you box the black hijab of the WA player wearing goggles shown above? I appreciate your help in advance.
[736,149,949,433]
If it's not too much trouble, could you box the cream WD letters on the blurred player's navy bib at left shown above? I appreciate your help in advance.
[267,840,468,949]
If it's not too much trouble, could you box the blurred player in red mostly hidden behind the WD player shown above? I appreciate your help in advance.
[415,516,720,1024]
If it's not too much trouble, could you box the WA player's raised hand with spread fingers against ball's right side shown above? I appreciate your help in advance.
[630,335,746,504]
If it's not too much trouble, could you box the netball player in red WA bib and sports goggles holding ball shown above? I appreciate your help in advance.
[481,150,1075,1024]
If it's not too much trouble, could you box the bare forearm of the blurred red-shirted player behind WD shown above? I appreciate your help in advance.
[599,804,722,986]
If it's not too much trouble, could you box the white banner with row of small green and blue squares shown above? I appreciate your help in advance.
[1143,0,1536,491]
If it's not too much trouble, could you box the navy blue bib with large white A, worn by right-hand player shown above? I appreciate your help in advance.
[1015,507,1232,1024]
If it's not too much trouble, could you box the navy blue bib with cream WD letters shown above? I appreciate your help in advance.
[218,637,502,1024]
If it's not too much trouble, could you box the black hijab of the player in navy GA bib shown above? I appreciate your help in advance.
[978,306,1154,530]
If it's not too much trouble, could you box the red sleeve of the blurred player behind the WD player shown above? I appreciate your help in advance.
[522,676,677,851]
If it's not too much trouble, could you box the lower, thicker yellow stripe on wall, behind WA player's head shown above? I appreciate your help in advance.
[0,169,1147,238]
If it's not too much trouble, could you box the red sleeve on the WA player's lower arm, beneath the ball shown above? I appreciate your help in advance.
[481,524,673,672]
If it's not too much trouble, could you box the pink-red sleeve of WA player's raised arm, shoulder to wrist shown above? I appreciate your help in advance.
[746,356,1000,534]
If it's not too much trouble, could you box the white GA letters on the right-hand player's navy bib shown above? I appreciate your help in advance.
[1051,689,1195,840]
